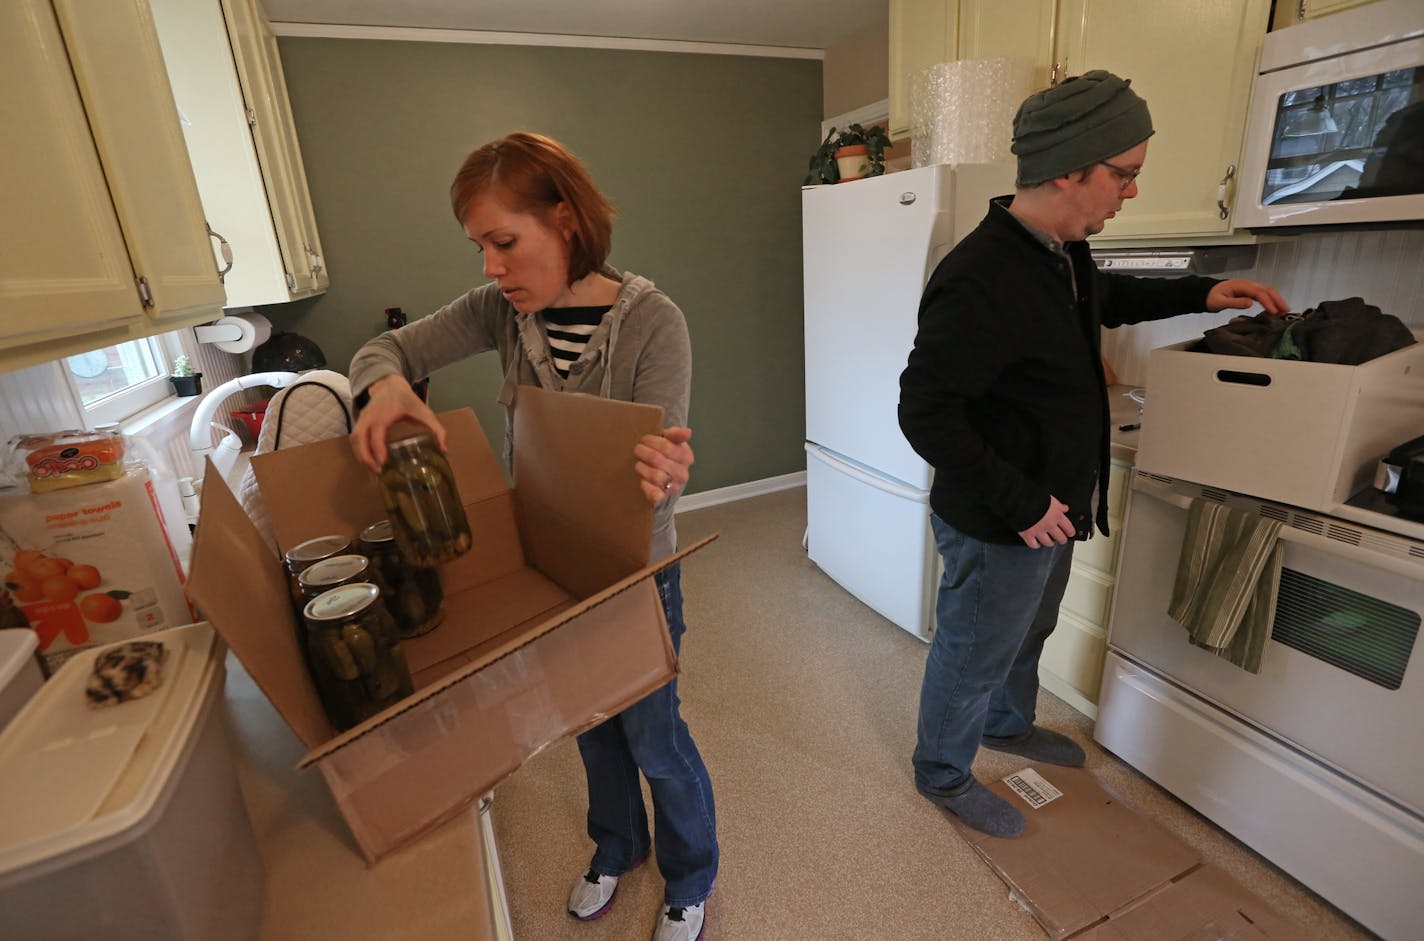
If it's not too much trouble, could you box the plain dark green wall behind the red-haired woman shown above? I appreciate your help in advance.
[262,38,822,493]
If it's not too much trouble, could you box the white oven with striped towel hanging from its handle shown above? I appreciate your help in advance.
[1095,471,1424,941]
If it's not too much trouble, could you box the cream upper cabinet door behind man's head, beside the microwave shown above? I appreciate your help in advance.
[1058,0,1270,241]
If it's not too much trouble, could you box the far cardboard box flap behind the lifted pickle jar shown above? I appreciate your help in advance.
[252,409,508,551]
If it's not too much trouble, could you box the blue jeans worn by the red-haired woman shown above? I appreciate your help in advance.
[578,564,718,907]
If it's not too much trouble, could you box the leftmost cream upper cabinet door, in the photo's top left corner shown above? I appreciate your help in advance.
[0,0,144,367]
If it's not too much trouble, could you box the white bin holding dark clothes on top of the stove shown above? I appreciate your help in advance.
[1136,340,1424,512]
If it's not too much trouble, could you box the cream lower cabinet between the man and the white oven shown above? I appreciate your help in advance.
[1038,460,1132,715]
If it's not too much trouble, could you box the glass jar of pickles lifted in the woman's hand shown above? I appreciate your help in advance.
[380,431,471,568]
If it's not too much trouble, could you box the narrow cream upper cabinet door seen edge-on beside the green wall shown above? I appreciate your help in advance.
[222,0,316,299]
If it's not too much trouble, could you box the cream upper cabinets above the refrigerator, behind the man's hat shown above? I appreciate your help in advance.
[890,0,1270,245]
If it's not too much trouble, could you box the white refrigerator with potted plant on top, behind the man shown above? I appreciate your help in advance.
[802,164,1014,641]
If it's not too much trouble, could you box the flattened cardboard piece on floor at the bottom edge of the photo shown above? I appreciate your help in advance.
[1074,866,1307,941]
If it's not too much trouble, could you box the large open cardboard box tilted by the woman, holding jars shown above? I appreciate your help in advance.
[188,387,711,861]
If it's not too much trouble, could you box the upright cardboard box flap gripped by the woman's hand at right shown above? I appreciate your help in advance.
[514,386,662,598]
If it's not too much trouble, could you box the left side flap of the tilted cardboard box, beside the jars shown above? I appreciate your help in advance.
[188,458,334,749]
